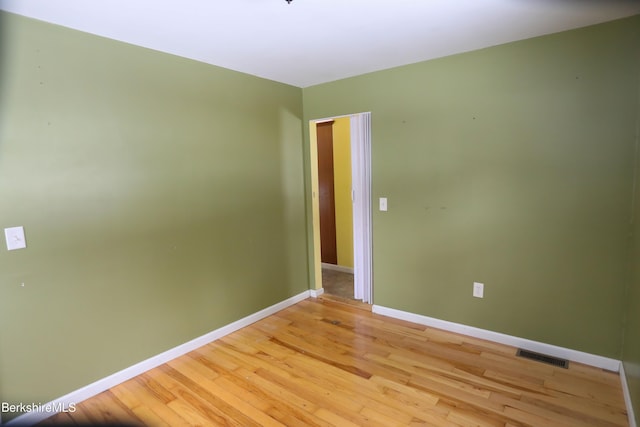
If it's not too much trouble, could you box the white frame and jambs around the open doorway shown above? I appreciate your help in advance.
[309,112,373,304]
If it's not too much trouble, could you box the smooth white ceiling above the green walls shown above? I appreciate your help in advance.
[0,0,640,87]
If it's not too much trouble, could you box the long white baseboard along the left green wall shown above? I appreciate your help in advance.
[5,291,310,426]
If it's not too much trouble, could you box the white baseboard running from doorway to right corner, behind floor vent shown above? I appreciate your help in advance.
[372,305,621,372]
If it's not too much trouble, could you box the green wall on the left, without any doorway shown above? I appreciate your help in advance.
[0,13,308,420]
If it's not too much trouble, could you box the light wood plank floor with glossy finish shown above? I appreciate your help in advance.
[44,298,628,427]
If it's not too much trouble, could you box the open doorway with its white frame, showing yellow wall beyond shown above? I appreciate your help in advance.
[309,113,373,304]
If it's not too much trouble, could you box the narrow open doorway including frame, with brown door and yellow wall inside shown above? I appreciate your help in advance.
[309,113,373,304]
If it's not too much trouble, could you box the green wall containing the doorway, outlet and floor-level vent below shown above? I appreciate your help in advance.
[303,16,640,358]
